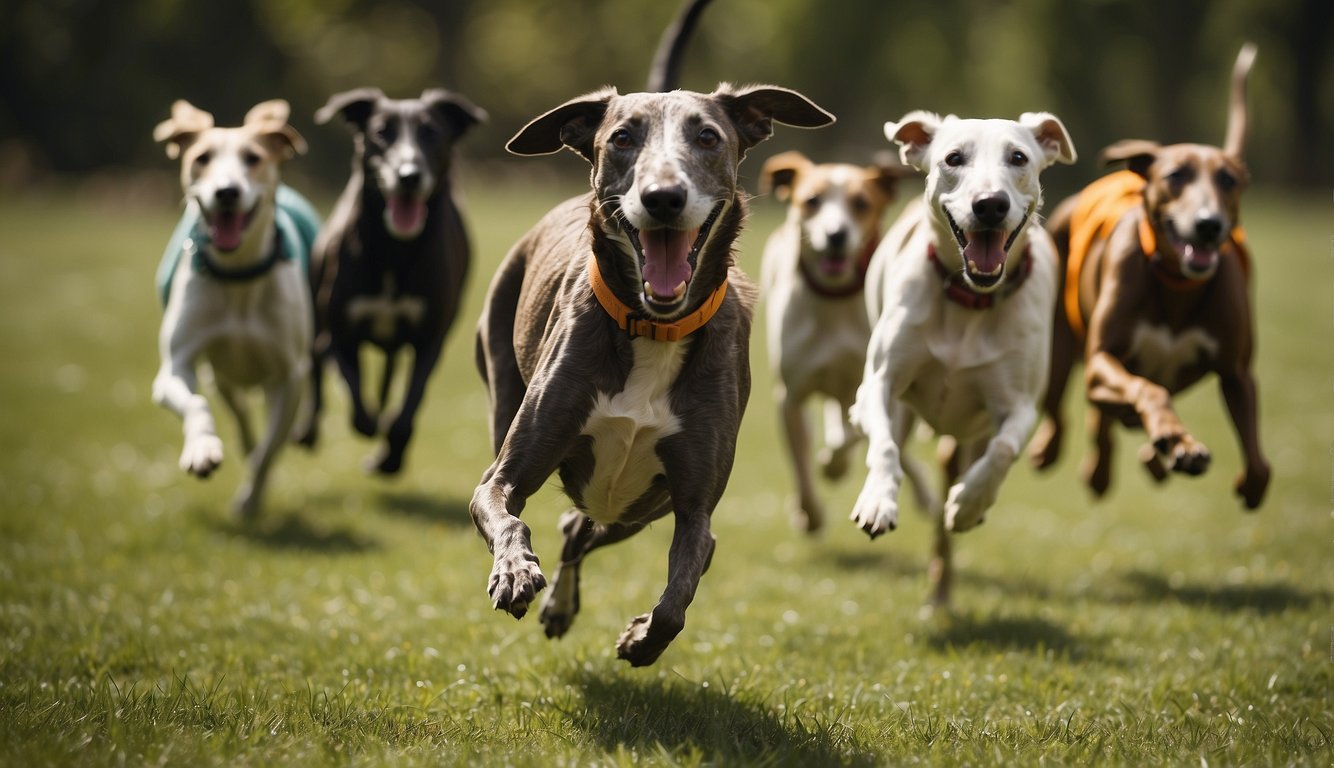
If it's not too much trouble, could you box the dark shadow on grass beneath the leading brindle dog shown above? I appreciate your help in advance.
[568,669,879,765]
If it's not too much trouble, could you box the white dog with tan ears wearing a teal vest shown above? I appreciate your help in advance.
[153,100,319,517]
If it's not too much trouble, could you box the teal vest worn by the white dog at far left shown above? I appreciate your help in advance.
[155,185,320,307]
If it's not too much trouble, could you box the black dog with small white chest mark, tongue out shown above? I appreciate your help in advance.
[299,88,487,475]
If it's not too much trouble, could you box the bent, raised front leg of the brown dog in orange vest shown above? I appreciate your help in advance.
[1085,351,1210,475]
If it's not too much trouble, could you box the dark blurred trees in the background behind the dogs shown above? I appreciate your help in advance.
[0,0,1334,193]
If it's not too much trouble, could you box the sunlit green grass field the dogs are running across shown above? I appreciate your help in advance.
[0,177,1334,767]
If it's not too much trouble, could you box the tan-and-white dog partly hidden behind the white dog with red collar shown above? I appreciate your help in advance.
[760,152,912,532]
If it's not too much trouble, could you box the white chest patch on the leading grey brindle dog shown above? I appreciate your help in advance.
[580,339,690,523]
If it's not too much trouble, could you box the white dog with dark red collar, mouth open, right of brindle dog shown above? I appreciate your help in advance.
[851,112,1075,604]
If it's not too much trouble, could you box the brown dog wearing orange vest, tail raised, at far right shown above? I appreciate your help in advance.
[1034,44,1270,509]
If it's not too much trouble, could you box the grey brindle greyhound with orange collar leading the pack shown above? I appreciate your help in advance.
[471,3,834,667]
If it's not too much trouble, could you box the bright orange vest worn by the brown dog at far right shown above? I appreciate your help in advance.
[1065,171,1250,340]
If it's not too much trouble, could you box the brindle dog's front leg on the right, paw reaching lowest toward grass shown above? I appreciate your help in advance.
[616,507,716,667]
